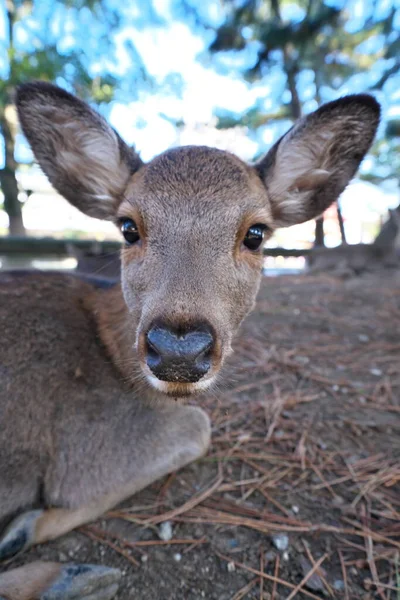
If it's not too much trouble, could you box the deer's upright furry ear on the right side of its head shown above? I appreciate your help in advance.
[255,94,380,227]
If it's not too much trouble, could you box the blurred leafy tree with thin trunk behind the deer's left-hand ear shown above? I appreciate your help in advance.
[0,0,143,235]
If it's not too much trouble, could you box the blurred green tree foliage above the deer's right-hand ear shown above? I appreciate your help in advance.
[202,0,400,244]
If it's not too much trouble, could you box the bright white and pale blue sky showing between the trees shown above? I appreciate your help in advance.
[0,0,400,243]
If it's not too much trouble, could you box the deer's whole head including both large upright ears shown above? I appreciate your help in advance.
[17,82,379,396]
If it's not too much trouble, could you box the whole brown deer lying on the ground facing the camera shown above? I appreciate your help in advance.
[0,81,380,600]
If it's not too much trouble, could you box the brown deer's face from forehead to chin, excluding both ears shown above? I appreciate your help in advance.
[117,147,273,395]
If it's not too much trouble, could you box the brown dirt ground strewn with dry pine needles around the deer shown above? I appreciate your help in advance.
[7,272,400,600]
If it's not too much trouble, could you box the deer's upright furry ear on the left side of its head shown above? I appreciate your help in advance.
[16,81,142,219]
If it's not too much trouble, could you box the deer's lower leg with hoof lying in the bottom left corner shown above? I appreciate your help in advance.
[0,561,121,600]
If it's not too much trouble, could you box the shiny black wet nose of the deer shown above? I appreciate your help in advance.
[146,324,214,383]
